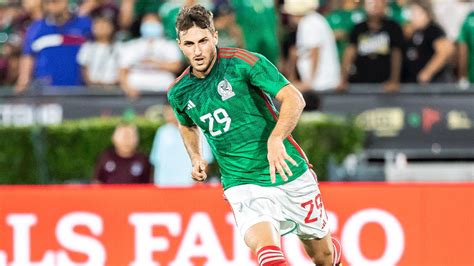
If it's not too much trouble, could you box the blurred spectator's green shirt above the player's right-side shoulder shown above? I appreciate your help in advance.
[233,0,280,65]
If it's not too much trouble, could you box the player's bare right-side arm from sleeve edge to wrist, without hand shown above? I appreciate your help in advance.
[270,84,305,139]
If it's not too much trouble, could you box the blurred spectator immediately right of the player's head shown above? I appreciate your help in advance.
[213,1,244,48]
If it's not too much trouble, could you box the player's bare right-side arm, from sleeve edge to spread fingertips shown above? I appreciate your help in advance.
[267,84,306,183]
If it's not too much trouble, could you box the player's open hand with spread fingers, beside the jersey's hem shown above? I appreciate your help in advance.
[267,137,298,183]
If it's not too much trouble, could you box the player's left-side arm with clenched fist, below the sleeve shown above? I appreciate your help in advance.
[179,124,207,181]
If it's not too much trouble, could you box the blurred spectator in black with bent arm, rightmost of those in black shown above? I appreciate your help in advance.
[402,0,454,83]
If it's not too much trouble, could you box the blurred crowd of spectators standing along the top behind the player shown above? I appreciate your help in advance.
[0,0,474,95]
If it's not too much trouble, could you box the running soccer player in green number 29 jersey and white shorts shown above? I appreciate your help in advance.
[168,5,341,266]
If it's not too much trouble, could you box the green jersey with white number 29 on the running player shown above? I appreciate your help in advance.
[168,48,308,189]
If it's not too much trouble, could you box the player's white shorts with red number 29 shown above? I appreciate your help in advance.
[224,170,329,239]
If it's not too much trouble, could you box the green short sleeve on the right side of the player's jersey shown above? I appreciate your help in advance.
[249,54,290,97]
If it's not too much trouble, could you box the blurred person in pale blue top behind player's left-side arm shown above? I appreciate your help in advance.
[150,105,213,186]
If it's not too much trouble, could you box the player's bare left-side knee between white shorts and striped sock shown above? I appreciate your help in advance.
[244,221,280,253]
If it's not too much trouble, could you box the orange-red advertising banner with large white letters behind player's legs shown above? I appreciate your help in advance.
[0,183,474,266]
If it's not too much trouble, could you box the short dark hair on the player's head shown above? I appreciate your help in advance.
[176,5,216,38]
